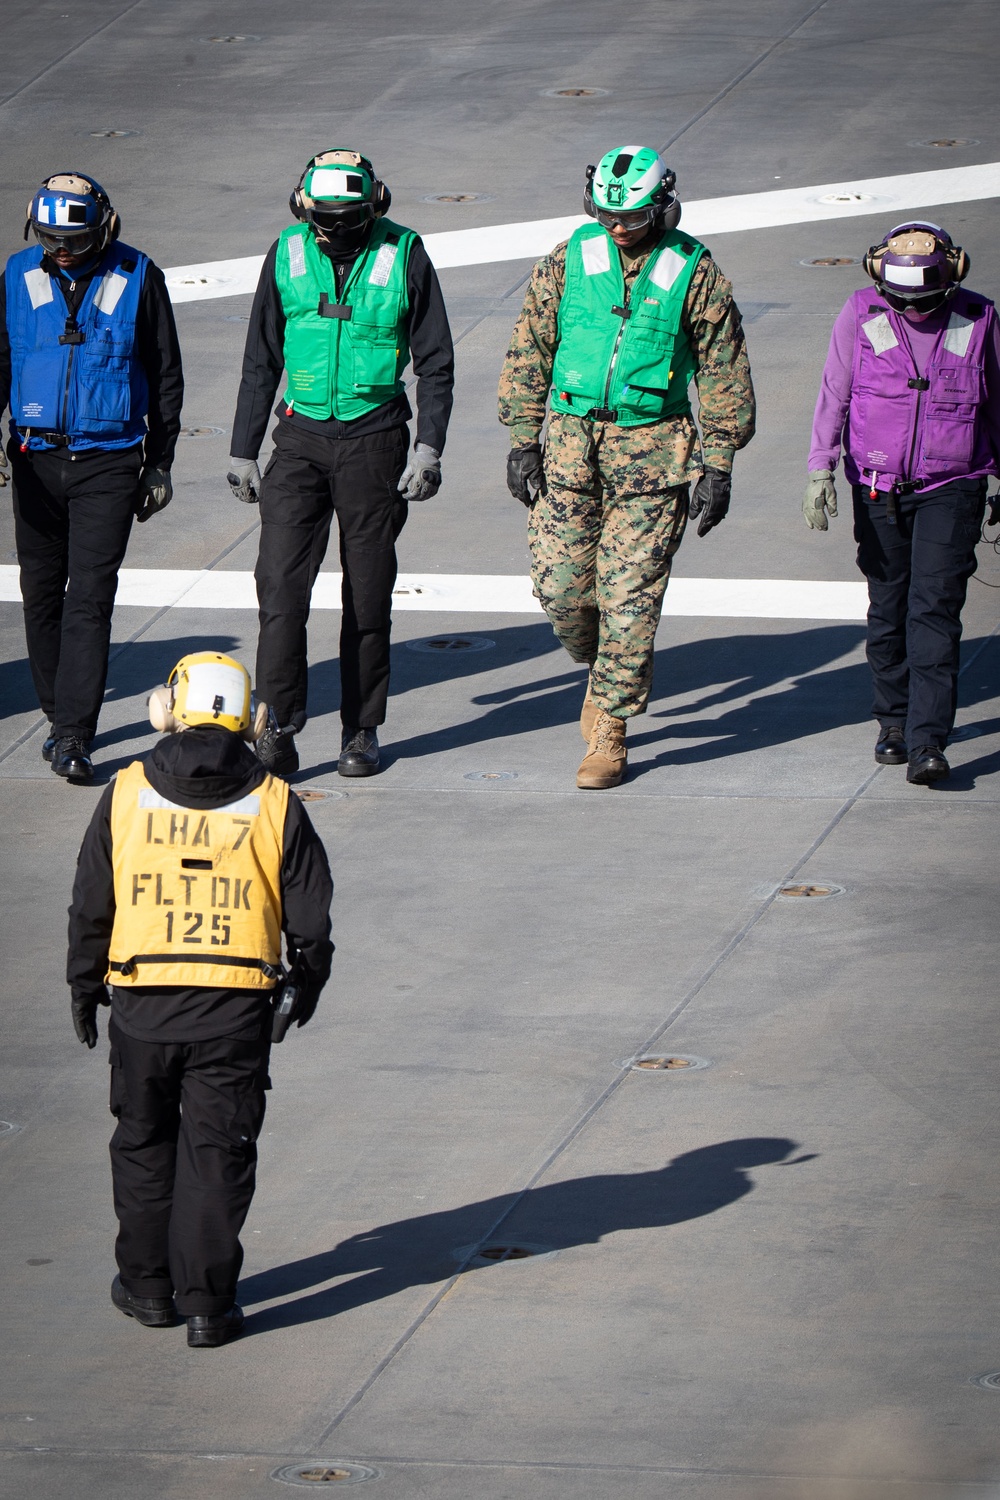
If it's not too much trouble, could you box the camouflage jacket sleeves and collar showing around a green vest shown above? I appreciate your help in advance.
[499,243,756,482]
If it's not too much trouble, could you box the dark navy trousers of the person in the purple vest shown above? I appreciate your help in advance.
[853,479,987,752]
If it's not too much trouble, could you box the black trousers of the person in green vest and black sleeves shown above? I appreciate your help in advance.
[255,422,409,729]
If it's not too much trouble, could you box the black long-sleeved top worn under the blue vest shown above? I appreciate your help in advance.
[0,255,184,468]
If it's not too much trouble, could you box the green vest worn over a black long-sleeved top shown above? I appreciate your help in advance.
[274,219,417,422]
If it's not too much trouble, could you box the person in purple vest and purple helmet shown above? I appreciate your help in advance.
[802,222,1000,786]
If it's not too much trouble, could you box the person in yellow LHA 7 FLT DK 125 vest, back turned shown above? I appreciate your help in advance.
[67,651,333,1349]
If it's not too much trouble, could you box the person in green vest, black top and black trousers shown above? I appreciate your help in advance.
[226,149,454,776]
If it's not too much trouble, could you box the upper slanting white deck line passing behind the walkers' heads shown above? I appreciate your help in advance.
[165,162,1000,302]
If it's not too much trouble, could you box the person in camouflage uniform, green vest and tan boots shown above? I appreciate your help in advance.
[499,146,754,789]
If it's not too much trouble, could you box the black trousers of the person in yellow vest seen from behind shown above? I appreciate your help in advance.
[108,1020,271,1317]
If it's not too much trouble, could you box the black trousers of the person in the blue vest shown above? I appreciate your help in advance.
[7,443,142,741]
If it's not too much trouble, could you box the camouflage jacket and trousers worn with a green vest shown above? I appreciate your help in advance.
[499,149,754,774]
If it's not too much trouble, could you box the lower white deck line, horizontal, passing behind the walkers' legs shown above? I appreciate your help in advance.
[0,566,868,620]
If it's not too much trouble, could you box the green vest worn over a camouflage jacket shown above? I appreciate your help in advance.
[552,224,705,428]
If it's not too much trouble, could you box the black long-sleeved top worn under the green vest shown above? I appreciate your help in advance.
[231,229,454,459]
